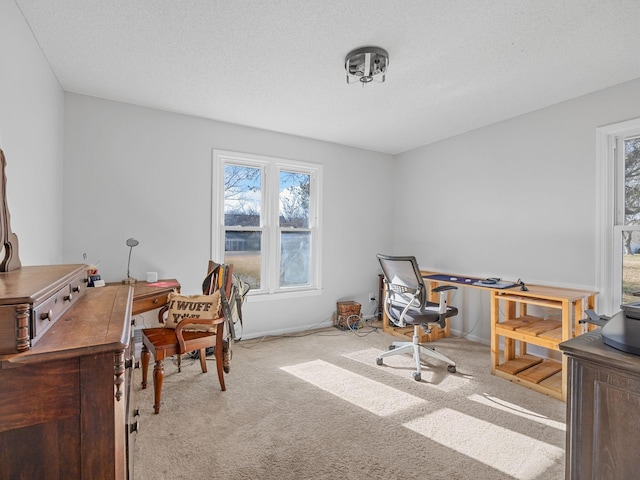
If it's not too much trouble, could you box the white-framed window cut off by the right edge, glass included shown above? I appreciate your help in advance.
[597,119,640,314]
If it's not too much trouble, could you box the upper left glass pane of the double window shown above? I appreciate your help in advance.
[224,164,262,227]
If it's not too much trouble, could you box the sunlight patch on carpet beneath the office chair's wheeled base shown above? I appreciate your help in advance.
[342,348,471,392]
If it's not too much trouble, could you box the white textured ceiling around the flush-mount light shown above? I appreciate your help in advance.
[13,0,640,154]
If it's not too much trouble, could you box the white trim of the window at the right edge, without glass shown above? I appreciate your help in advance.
[596,118,640,315]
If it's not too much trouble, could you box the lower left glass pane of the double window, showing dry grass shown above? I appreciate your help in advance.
[224,230,262,290]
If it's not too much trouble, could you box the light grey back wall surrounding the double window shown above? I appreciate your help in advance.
[63,93,392,336]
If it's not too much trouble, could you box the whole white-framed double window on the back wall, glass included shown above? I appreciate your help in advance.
[212,150,322,294]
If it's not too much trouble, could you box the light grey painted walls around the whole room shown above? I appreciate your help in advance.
[8,2,640,342]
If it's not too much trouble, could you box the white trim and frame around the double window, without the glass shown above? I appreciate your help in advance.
[210,149,322,299]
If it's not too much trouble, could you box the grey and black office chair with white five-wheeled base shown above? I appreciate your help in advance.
[376,255,458,382]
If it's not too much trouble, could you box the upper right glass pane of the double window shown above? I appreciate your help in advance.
[280,171,311,228]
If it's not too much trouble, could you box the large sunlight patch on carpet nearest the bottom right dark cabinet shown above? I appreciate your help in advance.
[403,408,564,480]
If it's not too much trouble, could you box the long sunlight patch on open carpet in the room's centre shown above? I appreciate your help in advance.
[281,360,427,417]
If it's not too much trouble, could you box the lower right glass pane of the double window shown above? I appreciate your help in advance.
[280,232,311,287]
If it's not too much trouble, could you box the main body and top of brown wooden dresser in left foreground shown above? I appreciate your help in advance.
[0,280,137,480]
